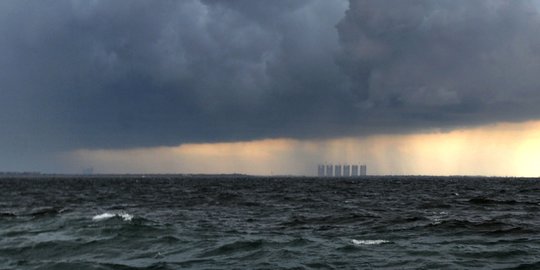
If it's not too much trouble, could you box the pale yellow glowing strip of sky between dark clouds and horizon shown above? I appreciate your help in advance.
[67,121,540,177]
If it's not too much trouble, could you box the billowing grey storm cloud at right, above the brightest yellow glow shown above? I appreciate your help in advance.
[337,0,540,127]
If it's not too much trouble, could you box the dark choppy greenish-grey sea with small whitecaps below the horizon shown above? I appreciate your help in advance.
[0,177,540,269]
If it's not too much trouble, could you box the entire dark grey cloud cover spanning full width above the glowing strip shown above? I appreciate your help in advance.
[0,0,540,171]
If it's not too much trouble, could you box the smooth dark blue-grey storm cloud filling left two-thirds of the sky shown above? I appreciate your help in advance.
[0,0,343,154]
